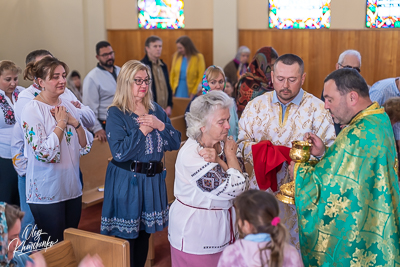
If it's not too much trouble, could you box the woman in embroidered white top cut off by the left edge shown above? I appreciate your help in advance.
[0,60,23,205]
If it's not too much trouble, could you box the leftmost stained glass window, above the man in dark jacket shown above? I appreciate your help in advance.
[138,0,185,29]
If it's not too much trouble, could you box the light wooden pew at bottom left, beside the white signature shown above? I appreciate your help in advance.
[40,228,130,267]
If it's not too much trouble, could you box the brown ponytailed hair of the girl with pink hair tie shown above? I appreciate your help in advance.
[235,190,288,267]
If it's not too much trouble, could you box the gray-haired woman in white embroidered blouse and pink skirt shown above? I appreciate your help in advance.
[168,91,248,266]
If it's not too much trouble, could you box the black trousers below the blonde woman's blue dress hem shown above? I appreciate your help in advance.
[127,231,150,267]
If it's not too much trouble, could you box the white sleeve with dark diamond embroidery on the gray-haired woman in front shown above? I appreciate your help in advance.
[196,162,248,200]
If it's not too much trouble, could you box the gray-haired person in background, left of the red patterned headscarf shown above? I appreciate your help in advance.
[224,46,250,87]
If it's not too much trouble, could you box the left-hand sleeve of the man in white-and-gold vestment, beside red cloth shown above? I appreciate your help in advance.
[238,102,257,165]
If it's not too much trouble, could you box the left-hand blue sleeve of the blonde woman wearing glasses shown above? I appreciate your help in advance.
[106,107,146,162]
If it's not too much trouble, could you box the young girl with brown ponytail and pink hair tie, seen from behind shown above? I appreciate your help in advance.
[218,190,304,267]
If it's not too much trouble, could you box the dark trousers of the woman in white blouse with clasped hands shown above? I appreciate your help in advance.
[29,196,82,242]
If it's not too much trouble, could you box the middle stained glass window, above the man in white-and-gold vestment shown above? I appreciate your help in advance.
[269,0,332,29]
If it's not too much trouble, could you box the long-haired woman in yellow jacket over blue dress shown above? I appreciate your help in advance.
[169,36,206,98]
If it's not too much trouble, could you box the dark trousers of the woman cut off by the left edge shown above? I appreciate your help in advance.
[0,158,19,206]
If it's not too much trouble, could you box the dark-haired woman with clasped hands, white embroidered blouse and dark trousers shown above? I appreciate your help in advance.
[21,57,93,241]
